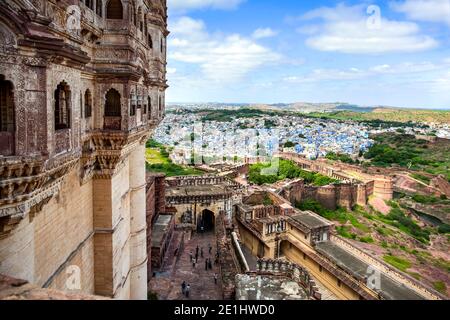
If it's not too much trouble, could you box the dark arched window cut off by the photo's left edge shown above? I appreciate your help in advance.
[0,75,16,156]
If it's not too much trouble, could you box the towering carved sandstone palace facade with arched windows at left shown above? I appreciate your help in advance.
[0,0,168,299]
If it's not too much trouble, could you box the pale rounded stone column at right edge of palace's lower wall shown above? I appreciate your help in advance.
[129,144,147,300]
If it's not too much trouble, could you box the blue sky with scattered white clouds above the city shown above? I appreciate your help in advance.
[167,0,450,108]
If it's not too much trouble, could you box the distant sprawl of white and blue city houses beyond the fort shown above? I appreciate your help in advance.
[154,112,373,164]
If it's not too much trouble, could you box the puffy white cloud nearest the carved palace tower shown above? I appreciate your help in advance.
[169,17,281,82]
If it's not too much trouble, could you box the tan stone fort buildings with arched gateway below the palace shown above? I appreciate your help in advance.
[151,175,442,300]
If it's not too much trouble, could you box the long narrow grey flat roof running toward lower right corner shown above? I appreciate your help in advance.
[316,241,424,300]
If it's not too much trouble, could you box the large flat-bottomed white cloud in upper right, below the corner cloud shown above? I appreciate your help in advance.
[299,4,437,54]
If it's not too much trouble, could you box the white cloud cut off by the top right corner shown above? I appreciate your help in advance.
[390,0,450,26]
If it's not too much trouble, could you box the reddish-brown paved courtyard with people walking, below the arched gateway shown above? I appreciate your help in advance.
[150,232,222,300]
